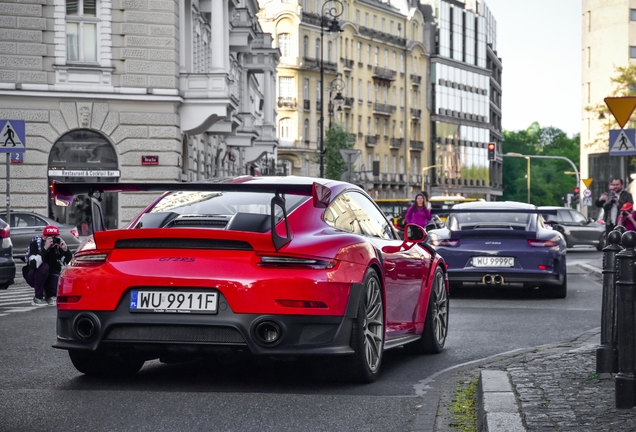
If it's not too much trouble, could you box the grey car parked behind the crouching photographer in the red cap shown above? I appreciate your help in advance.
[0,211,81,261]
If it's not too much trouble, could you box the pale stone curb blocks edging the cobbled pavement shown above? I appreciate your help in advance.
[477,370,526,432]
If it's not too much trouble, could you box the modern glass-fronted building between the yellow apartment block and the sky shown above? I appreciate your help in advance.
[429,0,503,200]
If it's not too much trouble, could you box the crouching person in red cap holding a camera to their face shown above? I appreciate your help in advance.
[22,225,73,306]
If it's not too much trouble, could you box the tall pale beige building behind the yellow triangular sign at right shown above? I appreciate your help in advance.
[580,0,636,217]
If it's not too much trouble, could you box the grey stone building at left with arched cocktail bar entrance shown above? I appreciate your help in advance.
[0,0,279,228]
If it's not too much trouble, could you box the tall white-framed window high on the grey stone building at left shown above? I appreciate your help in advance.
[66,0,99,63]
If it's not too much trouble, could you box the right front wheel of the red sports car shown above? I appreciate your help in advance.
[405,267,449,354]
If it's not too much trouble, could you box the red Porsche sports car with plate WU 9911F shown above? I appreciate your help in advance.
[53,177,448,382]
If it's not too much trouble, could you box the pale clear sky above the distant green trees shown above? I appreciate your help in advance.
[485,0,582,136]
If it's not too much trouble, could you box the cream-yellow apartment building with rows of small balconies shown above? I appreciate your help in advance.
[259,0,431,198]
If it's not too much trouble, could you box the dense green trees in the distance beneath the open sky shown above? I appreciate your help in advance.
[502,122,580,206]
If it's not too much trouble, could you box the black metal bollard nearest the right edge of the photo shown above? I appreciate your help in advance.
[615,231,636,408]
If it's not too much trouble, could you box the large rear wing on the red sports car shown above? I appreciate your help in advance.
[51,181,331,251]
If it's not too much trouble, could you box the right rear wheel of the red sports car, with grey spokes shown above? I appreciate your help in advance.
[347,269,384,383]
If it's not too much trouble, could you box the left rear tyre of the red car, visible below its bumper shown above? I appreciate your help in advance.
[68,350,144,377]
